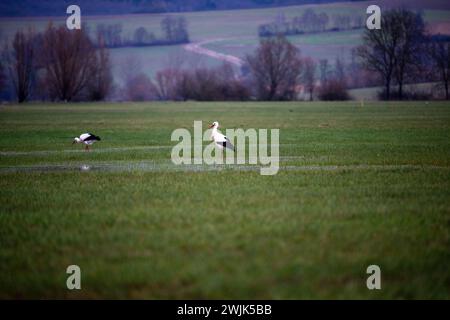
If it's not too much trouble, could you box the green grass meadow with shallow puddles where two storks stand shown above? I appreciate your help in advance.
[0,102,450,299]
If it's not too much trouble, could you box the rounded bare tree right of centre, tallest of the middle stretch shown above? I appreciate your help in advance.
[246,35,301,100]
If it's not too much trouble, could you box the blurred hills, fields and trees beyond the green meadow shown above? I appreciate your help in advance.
[0,0,450,102]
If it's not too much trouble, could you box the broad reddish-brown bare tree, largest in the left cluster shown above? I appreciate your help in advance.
[40,25,97,101]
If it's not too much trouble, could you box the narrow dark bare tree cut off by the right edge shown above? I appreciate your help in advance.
[429,41,450,100]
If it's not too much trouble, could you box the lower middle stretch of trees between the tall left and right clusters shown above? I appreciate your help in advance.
[119,35,349,101]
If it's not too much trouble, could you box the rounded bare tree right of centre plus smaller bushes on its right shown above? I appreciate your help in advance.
[246,35,349,101]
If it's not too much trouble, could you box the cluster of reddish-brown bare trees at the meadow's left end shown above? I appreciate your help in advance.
[2,24,113,103]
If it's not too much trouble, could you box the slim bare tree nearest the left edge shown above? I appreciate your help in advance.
[3,29,35,103]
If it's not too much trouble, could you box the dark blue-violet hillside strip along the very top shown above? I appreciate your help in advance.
[0,0,358,17]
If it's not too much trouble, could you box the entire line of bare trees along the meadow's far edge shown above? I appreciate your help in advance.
[0,9,450,102]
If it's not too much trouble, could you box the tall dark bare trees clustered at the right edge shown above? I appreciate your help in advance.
[357,8,450,100]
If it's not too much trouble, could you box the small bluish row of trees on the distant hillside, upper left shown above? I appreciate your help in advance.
[96,16,189,48]
